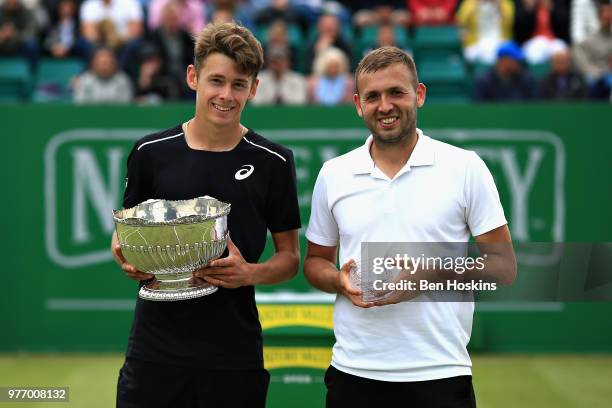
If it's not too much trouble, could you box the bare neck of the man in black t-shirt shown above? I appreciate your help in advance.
[183,116,247,152]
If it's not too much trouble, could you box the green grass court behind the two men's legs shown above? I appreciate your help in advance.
[0,354,612,408]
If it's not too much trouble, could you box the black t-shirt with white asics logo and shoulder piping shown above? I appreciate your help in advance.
[123,126,300,369]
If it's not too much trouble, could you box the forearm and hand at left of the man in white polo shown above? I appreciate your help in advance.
[304,241,372,307]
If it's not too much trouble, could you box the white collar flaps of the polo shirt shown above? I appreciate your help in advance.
[351,129,435,174]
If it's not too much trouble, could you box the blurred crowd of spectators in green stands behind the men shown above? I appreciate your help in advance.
[0,0,612,105]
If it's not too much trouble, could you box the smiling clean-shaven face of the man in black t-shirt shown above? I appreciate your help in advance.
[187,53,258,127]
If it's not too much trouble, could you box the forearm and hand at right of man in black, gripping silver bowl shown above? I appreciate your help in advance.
[193,230,300,288]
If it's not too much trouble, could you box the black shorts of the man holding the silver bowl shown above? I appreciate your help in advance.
[117,359,270,408]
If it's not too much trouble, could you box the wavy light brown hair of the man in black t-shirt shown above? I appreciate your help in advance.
[194,23,263,78]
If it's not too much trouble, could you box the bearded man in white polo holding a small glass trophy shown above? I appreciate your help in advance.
[304,47,516,408]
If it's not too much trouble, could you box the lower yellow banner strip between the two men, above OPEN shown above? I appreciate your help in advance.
[264,347,332,370]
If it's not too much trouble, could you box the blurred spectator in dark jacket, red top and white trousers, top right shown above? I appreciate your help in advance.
[514,0,570,64]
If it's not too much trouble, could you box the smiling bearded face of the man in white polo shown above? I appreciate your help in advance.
[354,63,426,144]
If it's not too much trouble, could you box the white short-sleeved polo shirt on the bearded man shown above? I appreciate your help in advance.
[306,129,507,382]
